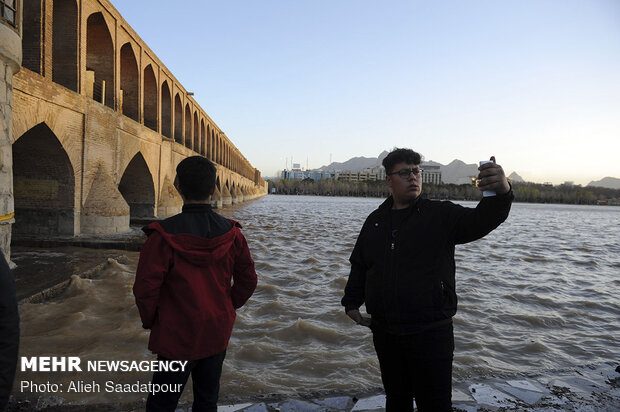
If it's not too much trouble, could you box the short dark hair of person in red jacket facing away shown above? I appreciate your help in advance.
[177,156,216,200]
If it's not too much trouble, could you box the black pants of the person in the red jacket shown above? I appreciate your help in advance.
[146,350,226,412]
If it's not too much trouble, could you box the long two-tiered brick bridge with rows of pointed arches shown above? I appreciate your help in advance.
[0,0,267,258]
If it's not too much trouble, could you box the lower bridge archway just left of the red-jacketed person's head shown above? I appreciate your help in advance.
[118,153,155,218]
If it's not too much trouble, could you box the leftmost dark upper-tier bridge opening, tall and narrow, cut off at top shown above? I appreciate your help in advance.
[22,1,43,74]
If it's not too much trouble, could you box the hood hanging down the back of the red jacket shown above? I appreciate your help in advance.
[143,220,241,264]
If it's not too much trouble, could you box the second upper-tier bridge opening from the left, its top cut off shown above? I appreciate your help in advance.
[52,0,78,92]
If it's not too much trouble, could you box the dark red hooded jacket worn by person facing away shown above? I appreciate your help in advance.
[133,216,257,360]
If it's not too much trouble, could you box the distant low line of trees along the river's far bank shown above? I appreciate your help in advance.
[268,178,620,205]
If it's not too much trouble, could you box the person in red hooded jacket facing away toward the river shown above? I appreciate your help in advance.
[133,156,257,412]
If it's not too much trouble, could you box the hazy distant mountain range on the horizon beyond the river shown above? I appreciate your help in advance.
[315,150,620,189]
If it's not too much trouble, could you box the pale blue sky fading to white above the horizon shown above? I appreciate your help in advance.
[111,0,620,185]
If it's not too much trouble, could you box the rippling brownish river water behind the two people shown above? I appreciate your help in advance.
[14,196,620,403]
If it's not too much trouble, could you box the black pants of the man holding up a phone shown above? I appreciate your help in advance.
[373,322,454,412]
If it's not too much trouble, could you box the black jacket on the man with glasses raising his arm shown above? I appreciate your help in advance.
[341,191,514,334]
